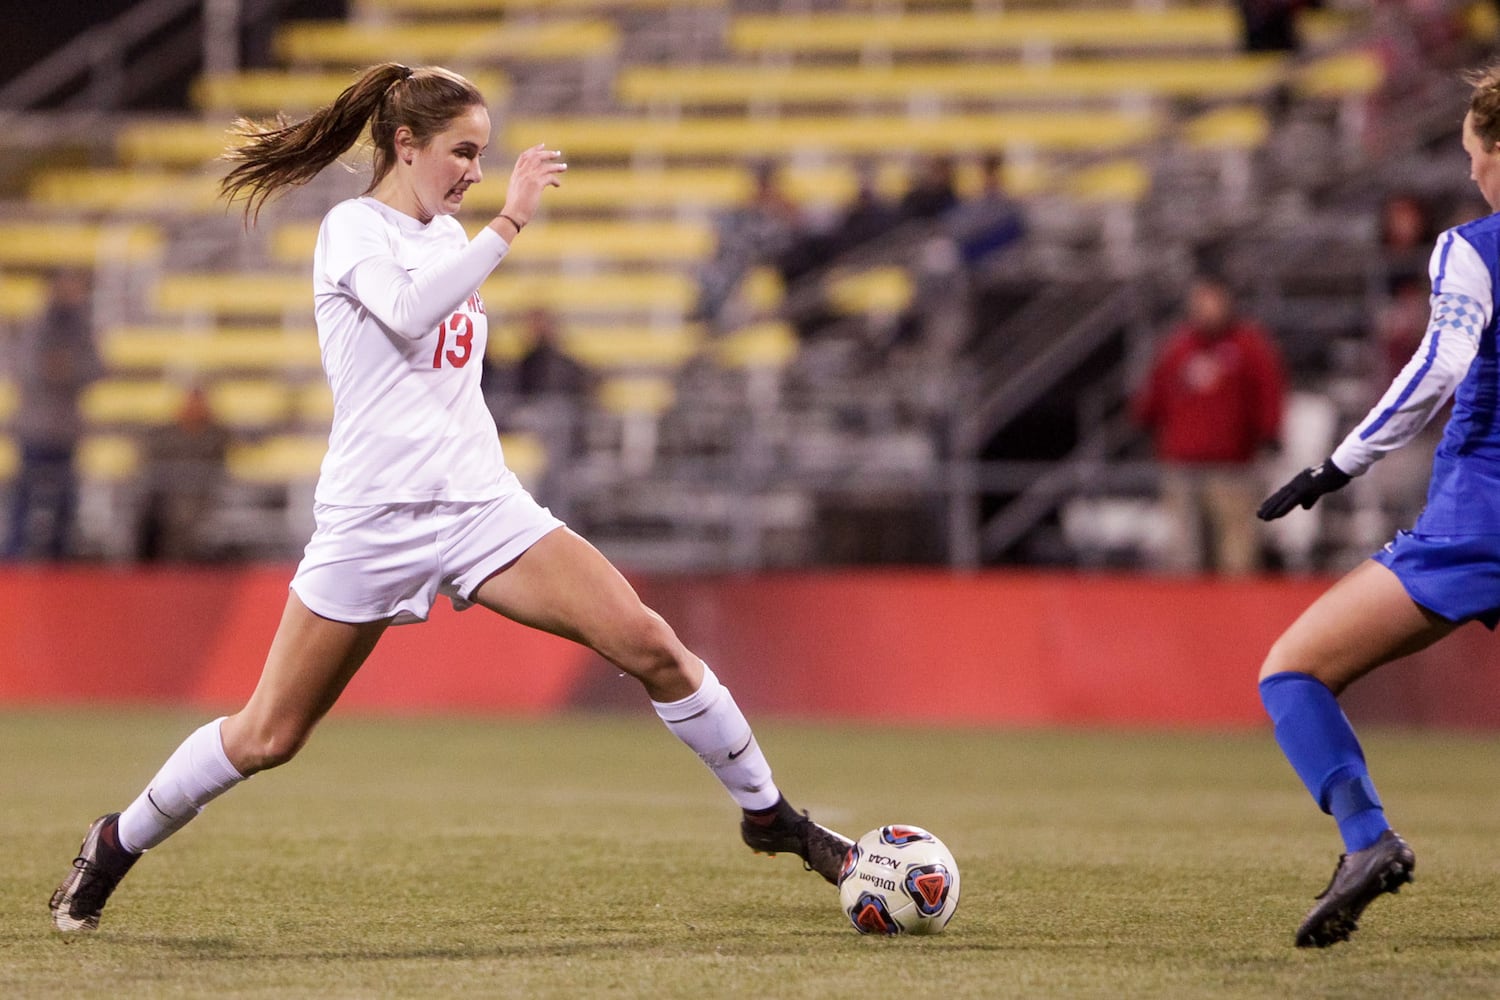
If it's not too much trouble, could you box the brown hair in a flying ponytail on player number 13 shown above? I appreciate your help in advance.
[219,63,485,222]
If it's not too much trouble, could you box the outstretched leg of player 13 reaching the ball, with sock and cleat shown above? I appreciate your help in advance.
[473,528,851,882]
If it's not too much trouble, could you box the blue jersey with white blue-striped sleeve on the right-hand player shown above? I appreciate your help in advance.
[1334,214,1500,535]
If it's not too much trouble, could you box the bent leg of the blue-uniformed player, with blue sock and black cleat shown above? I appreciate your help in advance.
[1260,561,1455,948]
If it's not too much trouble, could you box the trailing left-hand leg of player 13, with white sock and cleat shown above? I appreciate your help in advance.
[51,594,387,931]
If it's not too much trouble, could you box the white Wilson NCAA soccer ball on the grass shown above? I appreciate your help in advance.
[839,826,959,934]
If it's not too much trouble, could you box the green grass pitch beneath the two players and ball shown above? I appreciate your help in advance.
[0,712,1500,1000]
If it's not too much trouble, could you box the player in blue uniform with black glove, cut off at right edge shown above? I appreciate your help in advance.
[1260,64,1500,948]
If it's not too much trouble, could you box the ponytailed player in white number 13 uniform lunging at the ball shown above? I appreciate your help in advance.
[51,63,849,931]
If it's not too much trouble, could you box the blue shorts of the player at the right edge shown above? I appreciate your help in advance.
[1373,531,1500,631]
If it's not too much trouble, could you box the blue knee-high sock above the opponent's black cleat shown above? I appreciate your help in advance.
[1260,672,1391,852]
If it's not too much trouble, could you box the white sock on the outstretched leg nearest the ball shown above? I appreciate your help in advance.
[651,663,782,810]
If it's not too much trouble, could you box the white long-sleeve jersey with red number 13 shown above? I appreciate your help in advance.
[312,198,510,505]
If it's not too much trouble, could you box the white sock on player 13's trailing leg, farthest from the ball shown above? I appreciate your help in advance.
[119,718,245,855]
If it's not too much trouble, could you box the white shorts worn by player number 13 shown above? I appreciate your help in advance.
[291,477,563,625]
